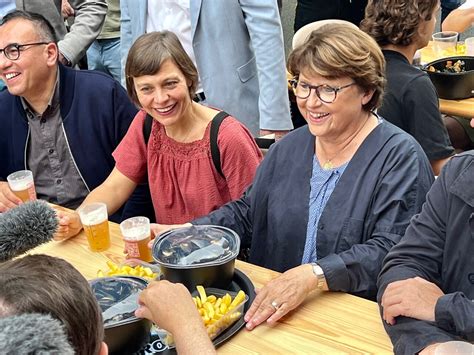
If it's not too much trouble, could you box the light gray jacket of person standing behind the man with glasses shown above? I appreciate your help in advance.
[15,0,107,65]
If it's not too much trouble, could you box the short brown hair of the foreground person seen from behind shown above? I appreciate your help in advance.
[0,255,104,355]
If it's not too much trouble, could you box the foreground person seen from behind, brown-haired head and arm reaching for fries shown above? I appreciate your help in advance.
[0,255,215,355]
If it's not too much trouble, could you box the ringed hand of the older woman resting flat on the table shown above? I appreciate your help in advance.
[244,264,317,330]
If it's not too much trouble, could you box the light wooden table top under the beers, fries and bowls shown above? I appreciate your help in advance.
[30,223,392,354]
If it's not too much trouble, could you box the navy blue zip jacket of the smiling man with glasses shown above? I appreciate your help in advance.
[0,65,152,220]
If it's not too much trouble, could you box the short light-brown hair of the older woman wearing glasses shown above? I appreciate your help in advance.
[288,23,385,111]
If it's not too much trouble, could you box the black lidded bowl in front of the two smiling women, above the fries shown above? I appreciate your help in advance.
[152,226,240,292]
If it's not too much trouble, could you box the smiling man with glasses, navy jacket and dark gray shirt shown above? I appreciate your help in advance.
[0,11,151,222]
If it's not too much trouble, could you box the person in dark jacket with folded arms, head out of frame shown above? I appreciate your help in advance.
[378,147,474,354]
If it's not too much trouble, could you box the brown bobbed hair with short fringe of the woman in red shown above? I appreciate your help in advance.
[125,31,199,105]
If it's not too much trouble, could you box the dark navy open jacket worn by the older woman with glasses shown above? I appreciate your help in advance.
[193,121,433,299]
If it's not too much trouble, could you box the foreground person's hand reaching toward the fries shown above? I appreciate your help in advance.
[135,280,204,335]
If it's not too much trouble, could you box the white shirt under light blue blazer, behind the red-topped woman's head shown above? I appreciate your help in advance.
[146,0,203,92]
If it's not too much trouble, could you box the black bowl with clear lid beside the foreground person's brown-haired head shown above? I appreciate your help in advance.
[89,276,152,355]
